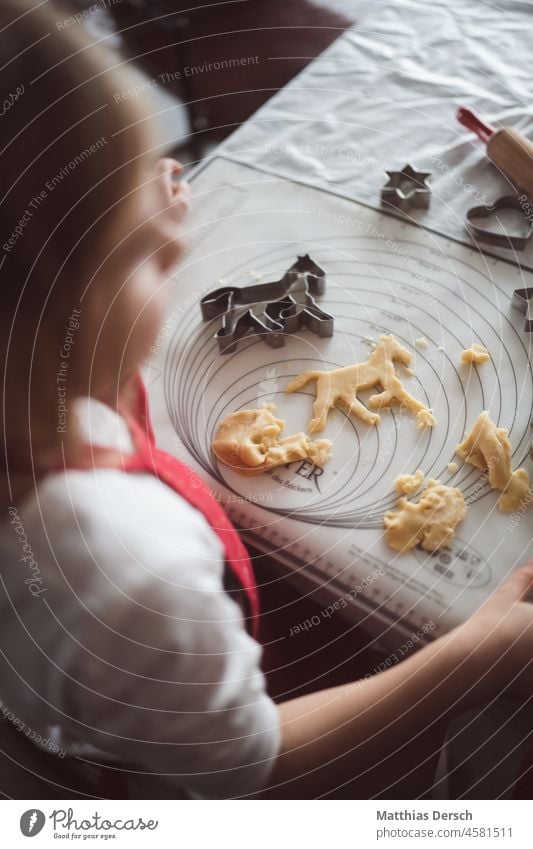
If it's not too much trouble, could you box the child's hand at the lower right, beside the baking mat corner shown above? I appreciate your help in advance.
[445,560,533,700]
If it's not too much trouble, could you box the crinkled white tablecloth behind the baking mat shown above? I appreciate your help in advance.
[217,0,533,265]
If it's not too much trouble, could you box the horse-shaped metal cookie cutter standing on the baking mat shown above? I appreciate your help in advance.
[200,254,334,354]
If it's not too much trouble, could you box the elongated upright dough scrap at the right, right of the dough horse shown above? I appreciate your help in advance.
[456,410,531,513]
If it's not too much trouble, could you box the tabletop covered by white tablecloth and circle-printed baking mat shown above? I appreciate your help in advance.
[147,2,533,647]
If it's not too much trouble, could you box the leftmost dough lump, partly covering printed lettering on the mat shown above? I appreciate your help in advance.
[212,404,331,475]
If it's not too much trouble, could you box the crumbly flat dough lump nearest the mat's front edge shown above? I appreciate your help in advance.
[383,473,467,552]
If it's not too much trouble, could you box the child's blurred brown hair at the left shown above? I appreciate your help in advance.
[0,0,145,470]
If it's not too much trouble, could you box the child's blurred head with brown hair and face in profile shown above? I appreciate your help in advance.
[0,0,183,460]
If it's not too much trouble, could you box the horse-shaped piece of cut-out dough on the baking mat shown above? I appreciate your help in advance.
[285,336,436,433]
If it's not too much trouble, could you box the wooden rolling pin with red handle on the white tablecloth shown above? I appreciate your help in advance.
[457,107,533,195]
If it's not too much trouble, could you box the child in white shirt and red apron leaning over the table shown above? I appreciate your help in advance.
[0,0,533,798]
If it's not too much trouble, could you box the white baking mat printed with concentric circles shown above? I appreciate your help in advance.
[146,157,533,633]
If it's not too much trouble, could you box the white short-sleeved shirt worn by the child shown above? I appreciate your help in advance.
[0,399,279,798]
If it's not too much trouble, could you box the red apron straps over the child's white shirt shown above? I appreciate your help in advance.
[70,372,259,637]
